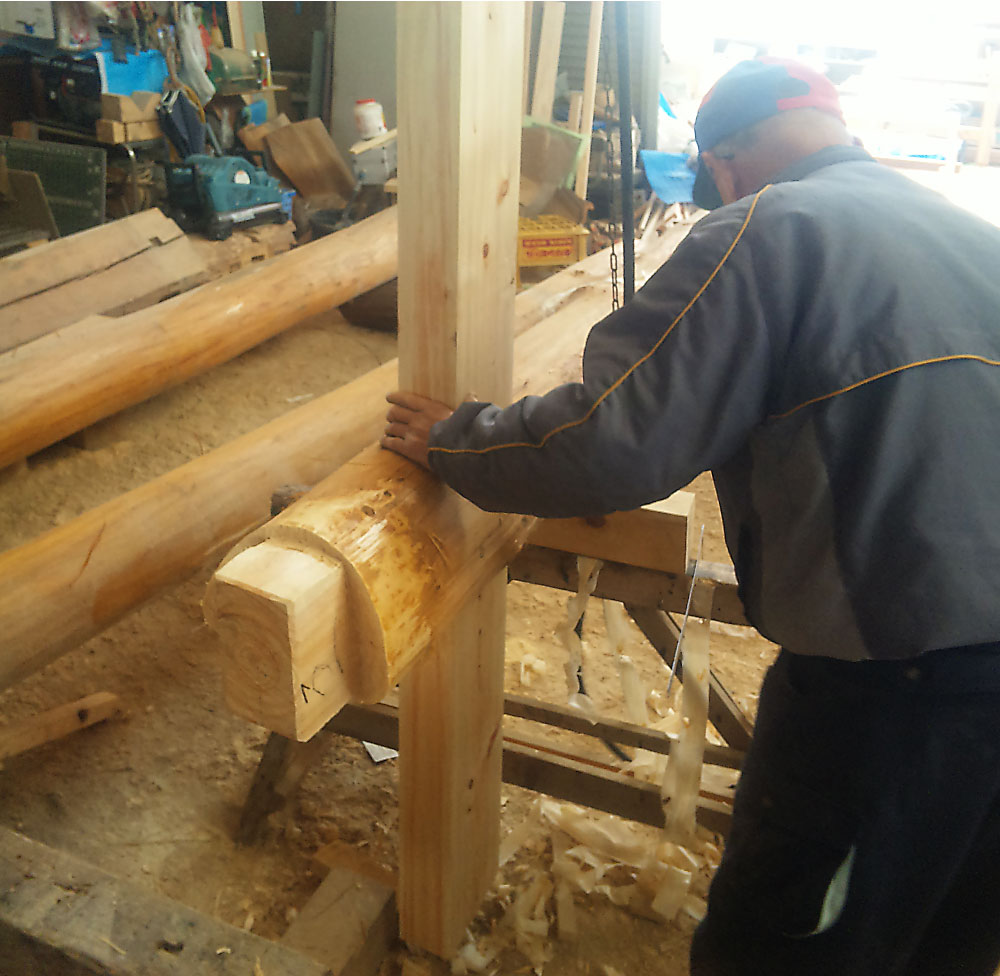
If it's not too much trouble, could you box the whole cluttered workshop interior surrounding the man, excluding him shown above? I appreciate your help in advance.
[0,0,1000,976]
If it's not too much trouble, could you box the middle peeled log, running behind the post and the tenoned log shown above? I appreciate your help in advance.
[0,223,688,690]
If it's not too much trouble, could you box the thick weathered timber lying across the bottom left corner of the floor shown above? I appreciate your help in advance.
[0,828,329,976]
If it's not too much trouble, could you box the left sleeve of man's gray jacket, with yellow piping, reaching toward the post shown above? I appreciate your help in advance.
[429,191,775,517]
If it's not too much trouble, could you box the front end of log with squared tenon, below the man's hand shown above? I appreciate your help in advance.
[206,445,534,739]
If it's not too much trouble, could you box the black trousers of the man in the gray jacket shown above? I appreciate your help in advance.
[691,643,1000,976]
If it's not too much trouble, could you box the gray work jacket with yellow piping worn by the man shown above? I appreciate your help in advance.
[430,147,1000,659]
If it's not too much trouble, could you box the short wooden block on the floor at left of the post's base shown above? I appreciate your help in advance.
[281,867,399,976]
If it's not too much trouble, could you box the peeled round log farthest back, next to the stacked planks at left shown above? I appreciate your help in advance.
[0,209,396,467]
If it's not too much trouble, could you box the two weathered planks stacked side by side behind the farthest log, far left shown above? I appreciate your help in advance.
[0,210,209,351]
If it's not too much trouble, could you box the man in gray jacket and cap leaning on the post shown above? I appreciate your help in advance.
[383,59,1000,976]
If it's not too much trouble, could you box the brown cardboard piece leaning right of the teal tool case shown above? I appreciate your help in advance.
[266,119,356,207]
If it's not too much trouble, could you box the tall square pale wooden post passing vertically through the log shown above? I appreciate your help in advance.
[397,3,524,956]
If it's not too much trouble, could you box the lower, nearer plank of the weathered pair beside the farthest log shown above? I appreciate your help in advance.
[0,234,209,352]
